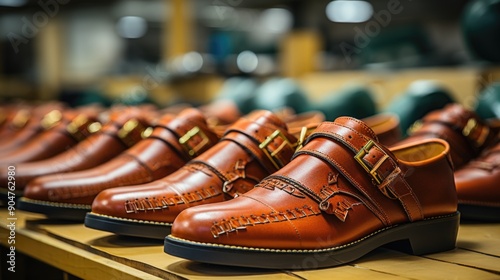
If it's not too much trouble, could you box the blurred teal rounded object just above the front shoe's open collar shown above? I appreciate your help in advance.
[386,80,454,136]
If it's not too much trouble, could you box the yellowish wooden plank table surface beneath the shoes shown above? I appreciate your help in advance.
[0,209,500,280]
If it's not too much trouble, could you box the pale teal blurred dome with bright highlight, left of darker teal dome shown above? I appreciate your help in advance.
[254,78,311,113]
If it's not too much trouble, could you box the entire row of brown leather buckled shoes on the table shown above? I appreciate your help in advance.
[0,95,500,269]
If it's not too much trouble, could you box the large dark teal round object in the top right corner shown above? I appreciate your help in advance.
[462,0,500,62]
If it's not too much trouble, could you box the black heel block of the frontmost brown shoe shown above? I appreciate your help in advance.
[385,212,460,255]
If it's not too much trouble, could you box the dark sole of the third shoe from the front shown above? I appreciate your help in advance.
[17,197,91,222]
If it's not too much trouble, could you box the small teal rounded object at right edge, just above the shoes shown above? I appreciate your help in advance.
[474,83,500,119]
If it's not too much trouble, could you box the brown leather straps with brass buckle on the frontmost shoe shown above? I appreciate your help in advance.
[294,122,424,224]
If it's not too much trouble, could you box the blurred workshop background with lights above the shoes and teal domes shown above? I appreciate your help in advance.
[0,0,500,111]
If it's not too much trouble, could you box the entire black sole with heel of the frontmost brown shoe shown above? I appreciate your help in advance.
[164,212,460,270]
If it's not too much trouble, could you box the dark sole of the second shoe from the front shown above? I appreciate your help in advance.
[85,213,172,240]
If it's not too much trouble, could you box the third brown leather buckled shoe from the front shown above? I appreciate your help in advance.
[18,109,219,221]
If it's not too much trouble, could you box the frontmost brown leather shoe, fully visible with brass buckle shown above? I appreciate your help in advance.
[164,117,459,269]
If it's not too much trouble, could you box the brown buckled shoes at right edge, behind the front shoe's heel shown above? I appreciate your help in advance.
[403,104,500,221]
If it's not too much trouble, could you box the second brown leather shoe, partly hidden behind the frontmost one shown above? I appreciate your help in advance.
[85,111,399,239]
